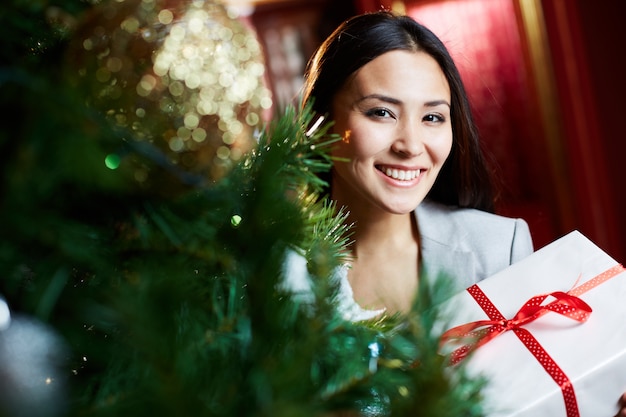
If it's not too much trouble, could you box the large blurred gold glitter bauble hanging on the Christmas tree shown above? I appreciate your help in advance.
[68,0,271,191]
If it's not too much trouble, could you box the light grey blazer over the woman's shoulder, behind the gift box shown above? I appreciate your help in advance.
[415,197,533,289]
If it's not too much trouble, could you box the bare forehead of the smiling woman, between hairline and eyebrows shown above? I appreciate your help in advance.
[344,51,450,100]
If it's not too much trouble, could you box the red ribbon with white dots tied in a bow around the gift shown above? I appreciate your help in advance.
[441,265,624,417]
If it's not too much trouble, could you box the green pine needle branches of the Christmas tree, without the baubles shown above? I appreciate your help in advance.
[0,0,481,417]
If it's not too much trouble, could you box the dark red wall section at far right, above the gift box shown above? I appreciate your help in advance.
[542,0,626,262]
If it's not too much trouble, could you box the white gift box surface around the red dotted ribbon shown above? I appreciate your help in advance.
[436,231,626,417]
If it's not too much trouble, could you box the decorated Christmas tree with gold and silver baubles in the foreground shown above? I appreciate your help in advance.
[0,0,481,416]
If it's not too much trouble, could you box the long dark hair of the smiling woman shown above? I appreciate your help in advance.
[303,11,494,212]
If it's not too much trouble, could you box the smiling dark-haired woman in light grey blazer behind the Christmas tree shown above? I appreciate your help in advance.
[294,12,533,320]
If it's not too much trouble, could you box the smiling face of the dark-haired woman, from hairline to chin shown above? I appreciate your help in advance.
[332,51,452,214]
